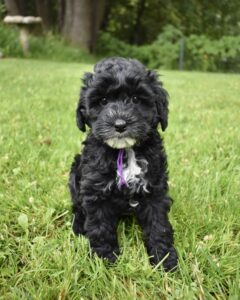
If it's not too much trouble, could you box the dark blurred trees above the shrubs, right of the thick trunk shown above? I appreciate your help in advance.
[102,0,240,45]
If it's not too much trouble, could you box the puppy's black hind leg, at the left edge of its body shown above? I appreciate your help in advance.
[69,155,85,235]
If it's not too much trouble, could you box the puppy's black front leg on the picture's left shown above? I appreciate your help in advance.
[84,203,119,262]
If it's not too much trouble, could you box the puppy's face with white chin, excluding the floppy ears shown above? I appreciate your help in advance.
[87,71,156,148]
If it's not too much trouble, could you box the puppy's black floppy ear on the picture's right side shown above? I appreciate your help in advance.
[148,71,168,131]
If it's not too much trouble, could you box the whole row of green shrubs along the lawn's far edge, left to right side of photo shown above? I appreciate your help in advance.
[0,23,240,72]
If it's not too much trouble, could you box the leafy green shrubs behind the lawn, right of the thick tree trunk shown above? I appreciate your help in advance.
[97,26,240,72]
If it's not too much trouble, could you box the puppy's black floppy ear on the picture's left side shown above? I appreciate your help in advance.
[76,73,93,132]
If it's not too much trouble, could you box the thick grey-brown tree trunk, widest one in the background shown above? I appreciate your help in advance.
[61,0,105,51]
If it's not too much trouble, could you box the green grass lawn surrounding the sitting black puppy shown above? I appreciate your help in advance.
[0,59,240,300]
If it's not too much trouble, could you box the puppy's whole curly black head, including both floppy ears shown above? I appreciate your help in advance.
[77,58,167,149]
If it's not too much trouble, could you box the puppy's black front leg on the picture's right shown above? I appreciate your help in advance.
[137,197,177,271]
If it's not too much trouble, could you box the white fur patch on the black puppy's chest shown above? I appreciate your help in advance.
[117,148,148,193]
